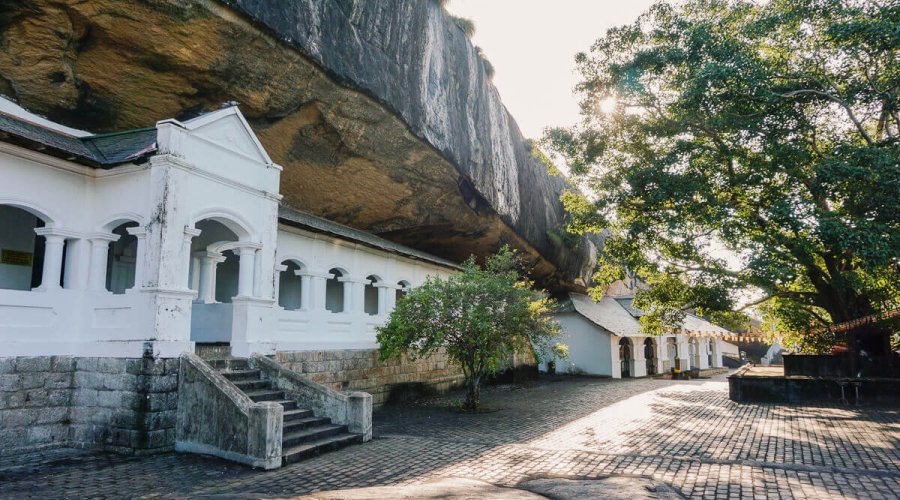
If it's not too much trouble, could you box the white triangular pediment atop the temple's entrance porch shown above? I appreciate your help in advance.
[184,106,272,164]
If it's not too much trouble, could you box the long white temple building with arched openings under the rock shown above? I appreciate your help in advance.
[0,100,456,357]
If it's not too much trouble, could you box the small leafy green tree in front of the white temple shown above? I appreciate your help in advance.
[378,246,560,410]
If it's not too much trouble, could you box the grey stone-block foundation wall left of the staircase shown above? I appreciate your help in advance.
[0,356,178,455]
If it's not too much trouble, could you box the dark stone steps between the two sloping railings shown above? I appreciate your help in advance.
[197,346,363,465]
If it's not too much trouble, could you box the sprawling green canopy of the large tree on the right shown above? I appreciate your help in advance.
[545,0,900,352]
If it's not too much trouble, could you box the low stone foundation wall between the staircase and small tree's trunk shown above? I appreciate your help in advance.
[275,349,463,406]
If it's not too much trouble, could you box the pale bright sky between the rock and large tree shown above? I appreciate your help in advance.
[447,0,654,139]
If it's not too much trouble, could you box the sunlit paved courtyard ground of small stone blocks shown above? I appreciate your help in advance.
[0,378,900,499]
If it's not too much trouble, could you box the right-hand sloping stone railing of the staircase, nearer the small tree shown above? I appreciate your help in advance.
[250,354,372,441]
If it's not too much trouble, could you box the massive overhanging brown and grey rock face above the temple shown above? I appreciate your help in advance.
[0,0,595,289]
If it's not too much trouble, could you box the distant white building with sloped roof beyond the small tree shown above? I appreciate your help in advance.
[541,293,734,378]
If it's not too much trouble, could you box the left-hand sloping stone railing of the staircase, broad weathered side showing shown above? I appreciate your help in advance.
[175,353,284,469]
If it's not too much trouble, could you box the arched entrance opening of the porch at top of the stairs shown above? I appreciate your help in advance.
[190,219,240,304]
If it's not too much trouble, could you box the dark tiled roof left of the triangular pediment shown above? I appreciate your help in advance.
[0,112,156,168]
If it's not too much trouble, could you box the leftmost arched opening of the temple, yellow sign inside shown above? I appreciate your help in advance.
[0,205,50,290]
